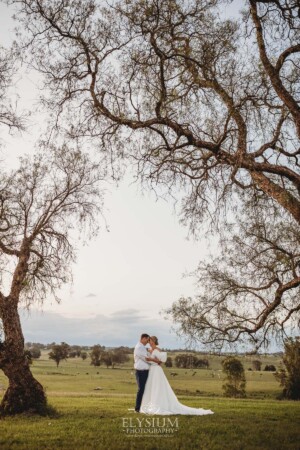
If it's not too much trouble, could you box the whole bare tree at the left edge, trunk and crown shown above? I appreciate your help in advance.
[0,146,101,414]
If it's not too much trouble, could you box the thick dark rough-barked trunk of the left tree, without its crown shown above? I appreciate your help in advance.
[0,297,47,414]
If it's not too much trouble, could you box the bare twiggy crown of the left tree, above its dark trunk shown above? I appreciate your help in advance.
[0,147,102,307]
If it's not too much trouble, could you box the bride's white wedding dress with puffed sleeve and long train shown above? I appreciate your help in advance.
[140,349,213,416]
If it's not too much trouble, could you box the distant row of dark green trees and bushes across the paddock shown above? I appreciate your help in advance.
[25,337,300,400]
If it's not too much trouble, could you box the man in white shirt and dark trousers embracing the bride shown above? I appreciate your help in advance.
[134,333,161,412]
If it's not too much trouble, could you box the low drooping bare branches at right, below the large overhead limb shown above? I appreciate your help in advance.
[167,204,300,350]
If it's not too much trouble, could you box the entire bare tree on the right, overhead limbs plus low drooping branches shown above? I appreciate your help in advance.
[6,0,300,345]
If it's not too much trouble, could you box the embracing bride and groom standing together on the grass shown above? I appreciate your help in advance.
[134,333,213,416]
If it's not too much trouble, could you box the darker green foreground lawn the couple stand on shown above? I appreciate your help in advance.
[0,394,300,450]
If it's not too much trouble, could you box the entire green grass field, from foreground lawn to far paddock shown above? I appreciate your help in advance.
[0,353,300,450]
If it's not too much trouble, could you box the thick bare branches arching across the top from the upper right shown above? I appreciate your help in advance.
[7,0,300,223]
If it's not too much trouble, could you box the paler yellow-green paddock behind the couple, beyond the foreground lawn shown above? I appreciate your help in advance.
[0,352,280,399]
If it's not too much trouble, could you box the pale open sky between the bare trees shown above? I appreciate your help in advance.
[0,2,239,348]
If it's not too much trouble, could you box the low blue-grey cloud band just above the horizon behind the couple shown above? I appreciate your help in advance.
[20,309,183,348]
